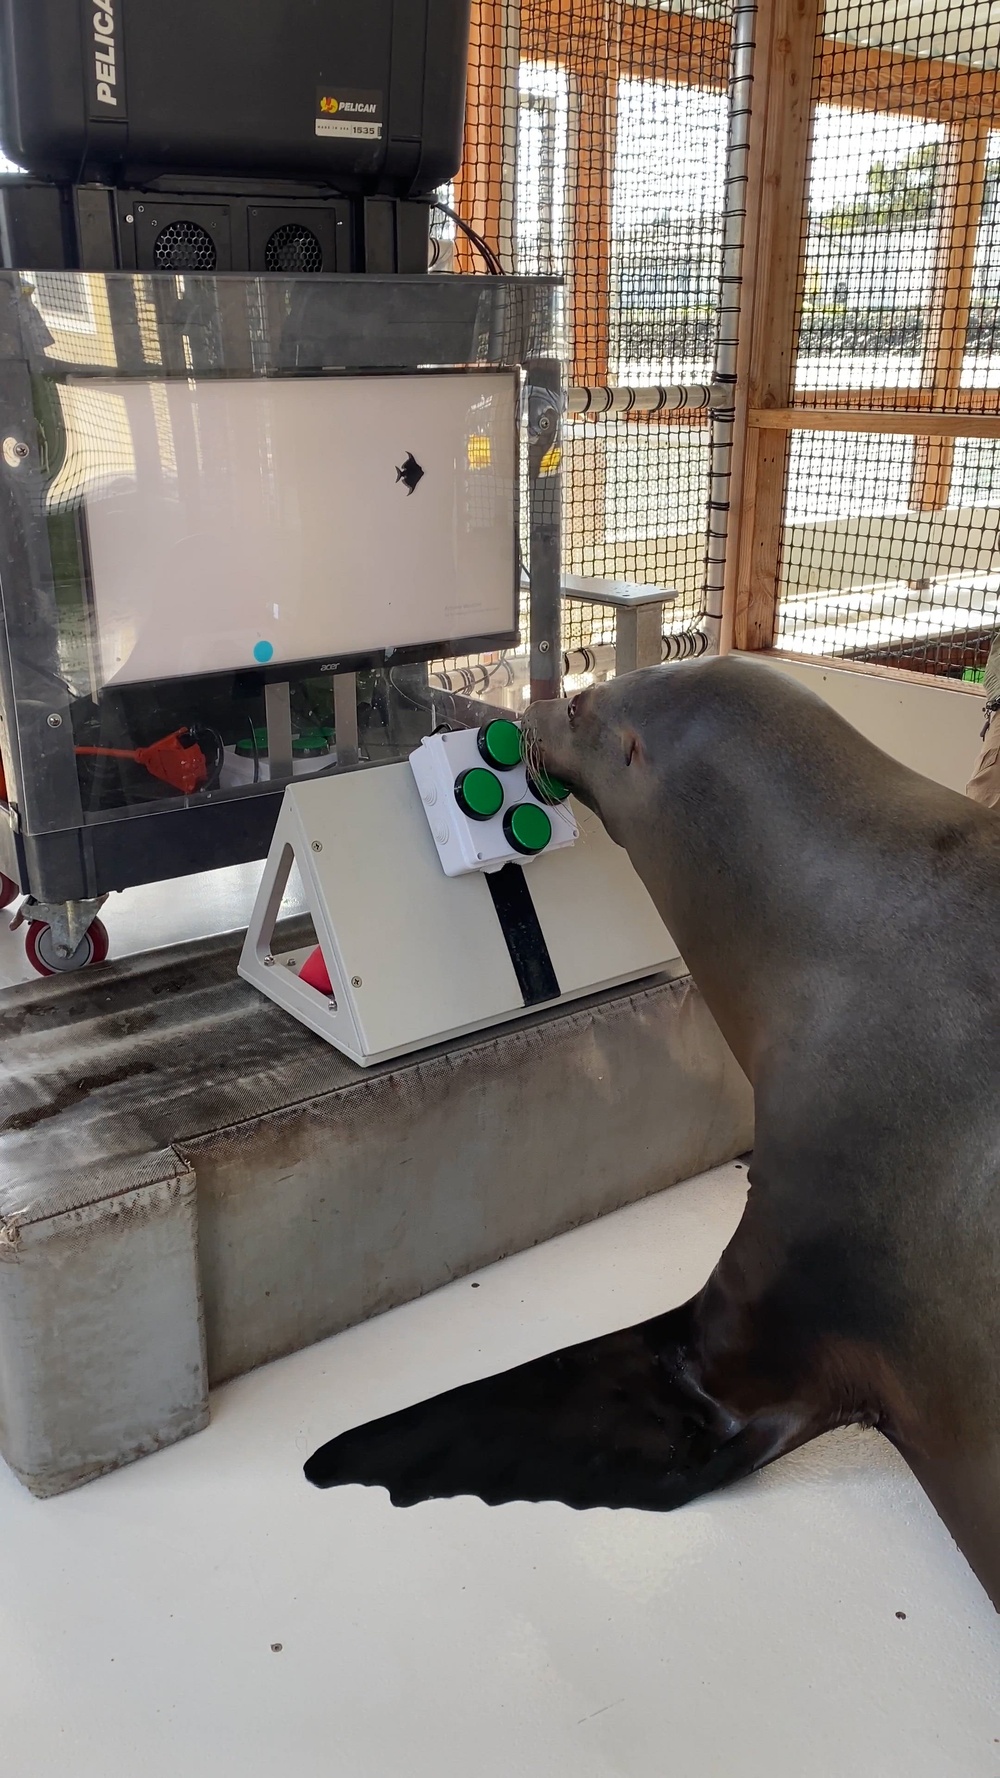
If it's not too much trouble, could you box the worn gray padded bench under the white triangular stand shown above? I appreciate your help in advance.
[0,933,753,1495]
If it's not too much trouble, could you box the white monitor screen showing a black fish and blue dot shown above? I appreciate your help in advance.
[48,372,518,685]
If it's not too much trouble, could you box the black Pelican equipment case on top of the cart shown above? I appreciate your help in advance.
[0,0,470,197]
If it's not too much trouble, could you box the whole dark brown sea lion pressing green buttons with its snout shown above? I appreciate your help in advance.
[306,656,1000,1607]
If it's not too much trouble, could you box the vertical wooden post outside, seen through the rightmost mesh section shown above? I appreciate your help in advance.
[909,119,989,512]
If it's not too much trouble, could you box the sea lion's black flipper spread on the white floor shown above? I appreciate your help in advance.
[306,1293,811,1511]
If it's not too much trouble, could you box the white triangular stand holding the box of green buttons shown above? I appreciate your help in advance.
[240,763,681,1067]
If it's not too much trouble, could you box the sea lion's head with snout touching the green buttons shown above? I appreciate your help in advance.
[523,667,673,846]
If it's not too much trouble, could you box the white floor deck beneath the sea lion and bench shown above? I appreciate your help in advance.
[0,873,1000,1778]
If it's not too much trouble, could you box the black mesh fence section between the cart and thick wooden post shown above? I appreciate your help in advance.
[432,0,730,682]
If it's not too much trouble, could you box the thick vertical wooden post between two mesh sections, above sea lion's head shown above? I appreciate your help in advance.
[726,0,820,649]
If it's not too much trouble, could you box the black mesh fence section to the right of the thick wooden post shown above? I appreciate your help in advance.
[776,0,1000,676]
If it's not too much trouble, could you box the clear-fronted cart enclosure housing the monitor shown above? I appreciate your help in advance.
[0,272,553,894]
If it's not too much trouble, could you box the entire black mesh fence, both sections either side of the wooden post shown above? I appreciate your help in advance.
[15,0,1000,697]
